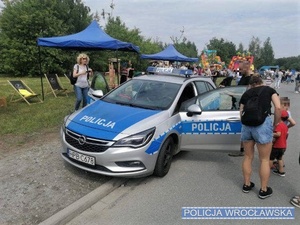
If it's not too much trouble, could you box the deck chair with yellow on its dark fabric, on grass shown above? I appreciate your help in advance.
[8,80,43,105]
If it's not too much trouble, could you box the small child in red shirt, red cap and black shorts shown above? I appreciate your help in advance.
[270,110,289,177]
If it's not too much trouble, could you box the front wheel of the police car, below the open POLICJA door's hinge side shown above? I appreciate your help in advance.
[154,137,174,177]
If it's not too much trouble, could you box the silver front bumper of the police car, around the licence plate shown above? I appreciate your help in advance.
[61,130,158,177]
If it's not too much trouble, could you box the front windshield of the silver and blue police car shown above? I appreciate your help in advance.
[102,79,180,110]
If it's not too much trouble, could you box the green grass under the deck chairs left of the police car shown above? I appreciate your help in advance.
[0,77,75,136]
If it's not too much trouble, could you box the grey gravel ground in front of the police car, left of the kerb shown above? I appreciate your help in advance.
[0,130,110,225]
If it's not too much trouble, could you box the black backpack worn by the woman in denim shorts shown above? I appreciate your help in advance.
[241,87,268,126]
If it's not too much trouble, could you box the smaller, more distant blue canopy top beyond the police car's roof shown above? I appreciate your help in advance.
[141,45,199,62]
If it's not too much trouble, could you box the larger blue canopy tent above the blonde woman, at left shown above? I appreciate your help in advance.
[37,20,140,98]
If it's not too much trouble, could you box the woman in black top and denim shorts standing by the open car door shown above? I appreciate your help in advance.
[240,76,281,199]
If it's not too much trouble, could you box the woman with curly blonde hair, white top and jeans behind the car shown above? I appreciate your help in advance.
[72,53,93,111]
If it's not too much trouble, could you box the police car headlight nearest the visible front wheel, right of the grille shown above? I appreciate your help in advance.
[112,127,155,148]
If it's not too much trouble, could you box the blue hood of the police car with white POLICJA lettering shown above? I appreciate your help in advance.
[66,100,161,140]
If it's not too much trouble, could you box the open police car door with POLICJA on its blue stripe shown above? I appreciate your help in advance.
[180,86,247,150]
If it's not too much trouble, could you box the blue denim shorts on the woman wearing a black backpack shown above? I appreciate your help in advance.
[241,116,273,144]
